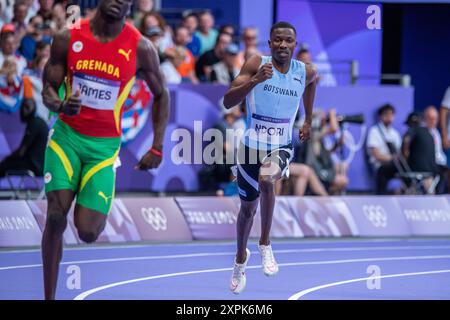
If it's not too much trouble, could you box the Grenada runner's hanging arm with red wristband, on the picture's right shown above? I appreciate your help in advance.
[137,37,170,170]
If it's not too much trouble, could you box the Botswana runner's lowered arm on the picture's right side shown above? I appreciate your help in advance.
[300,64,317,140]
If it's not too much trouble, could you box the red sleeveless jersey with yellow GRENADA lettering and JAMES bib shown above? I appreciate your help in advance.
[60,19,141,137]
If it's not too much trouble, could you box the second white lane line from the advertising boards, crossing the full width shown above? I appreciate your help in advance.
[4,246,450,271]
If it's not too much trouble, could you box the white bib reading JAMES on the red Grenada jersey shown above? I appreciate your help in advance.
[72,73,120,110]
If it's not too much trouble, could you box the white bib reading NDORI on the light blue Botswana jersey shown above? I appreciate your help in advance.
[249,114,290,145]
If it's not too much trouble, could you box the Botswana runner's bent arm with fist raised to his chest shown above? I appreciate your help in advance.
[223,55,273,109]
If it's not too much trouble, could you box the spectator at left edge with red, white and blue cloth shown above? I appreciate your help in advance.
[0,57,23,113]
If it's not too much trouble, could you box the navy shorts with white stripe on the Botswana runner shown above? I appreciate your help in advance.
[237,144,293,201]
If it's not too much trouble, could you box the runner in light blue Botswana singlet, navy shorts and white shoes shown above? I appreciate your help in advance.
[223,22,316,294]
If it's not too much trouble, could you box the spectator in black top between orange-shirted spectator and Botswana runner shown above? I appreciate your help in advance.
[195,33,231,82]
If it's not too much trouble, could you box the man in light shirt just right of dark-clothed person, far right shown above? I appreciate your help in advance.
[424,106,448,193]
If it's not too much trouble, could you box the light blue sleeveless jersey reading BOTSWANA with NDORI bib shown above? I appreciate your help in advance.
[243,56,306,150]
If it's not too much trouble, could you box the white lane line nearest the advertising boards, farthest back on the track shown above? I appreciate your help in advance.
[0,238,450,255]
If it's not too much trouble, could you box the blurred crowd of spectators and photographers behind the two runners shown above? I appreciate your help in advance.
[0,0,450,196]
